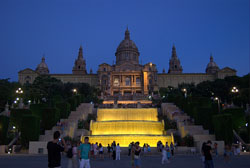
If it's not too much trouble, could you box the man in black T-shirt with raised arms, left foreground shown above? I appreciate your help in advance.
[47,131,67,168]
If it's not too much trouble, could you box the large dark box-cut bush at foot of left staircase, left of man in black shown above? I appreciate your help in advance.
[21,115,40,147]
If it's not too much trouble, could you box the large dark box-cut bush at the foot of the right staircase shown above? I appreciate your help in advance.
[213,114,233,144]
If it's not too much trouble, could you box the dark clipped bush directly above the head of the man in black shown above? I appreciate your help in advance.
[42,108,60,130]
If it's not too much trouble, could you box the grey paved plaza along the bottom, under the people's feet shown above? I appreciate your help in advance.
[0,155,250,168]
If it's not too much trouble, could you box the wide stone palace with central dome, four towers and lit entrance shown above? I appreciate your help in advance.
[18,29,236,96]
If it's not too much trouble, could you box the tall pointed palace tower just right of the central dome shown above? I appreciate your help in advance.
[168,45,183,74]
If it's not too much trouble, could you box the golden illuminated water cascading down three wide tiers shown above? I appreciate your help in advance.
[82,108,174,147]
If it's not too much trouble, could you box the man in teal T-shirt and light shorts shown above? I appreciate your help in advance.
[78,137,91,168]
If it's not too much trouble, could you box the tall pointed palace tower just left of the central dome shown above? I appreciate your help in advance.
[72,46,87,75]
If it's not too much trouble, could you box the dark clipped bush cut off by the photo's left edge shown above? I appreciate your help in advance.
[0,116,9,145]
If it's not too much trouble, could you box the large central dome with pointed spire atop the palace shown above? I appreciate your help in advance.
[115,28,140,65]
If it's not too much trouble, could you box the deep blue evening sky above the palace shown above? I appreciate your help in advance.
[0,0,249,80]
